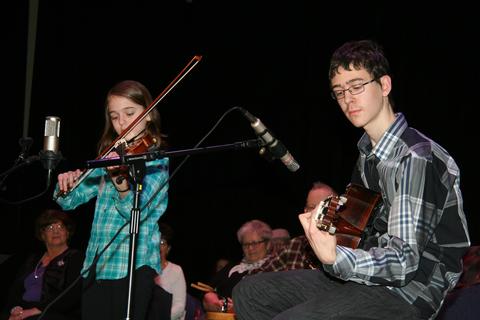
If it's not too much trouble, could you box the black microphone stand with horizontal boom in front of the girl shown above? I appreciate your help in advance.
[87,138,264,320]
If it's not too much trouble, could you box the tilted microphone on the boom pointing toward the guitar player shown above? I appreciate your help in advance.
[238,107,300,172]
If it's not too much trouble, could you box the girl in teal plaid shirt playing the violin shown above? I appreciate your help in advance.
[55,80,168,319]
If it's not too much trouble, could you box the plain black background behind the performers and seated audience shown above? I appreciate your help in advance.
[0,0,480,304]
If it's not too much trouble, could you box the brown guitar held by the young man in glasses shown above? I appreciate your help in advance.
[314,183,380,249]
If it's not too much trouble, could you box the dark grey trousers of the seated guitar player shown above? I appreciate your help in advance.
[233,270,419,320]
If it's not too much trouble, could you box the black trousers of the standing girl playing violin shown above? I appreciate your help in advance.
[82,266,155,320]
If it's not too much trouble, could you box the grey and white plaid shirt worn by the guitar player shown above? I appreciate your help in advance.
[324,113,470,318]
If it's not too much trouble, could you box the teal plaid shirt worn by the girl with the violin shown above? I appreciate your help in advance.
[55,158,169,280]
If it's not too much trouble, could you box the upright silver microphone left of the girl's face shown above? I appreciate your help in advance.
[39,116,62,185]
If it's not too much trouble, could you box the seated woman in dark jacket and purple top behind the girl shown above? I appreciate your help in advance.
[1,210,84,320]
